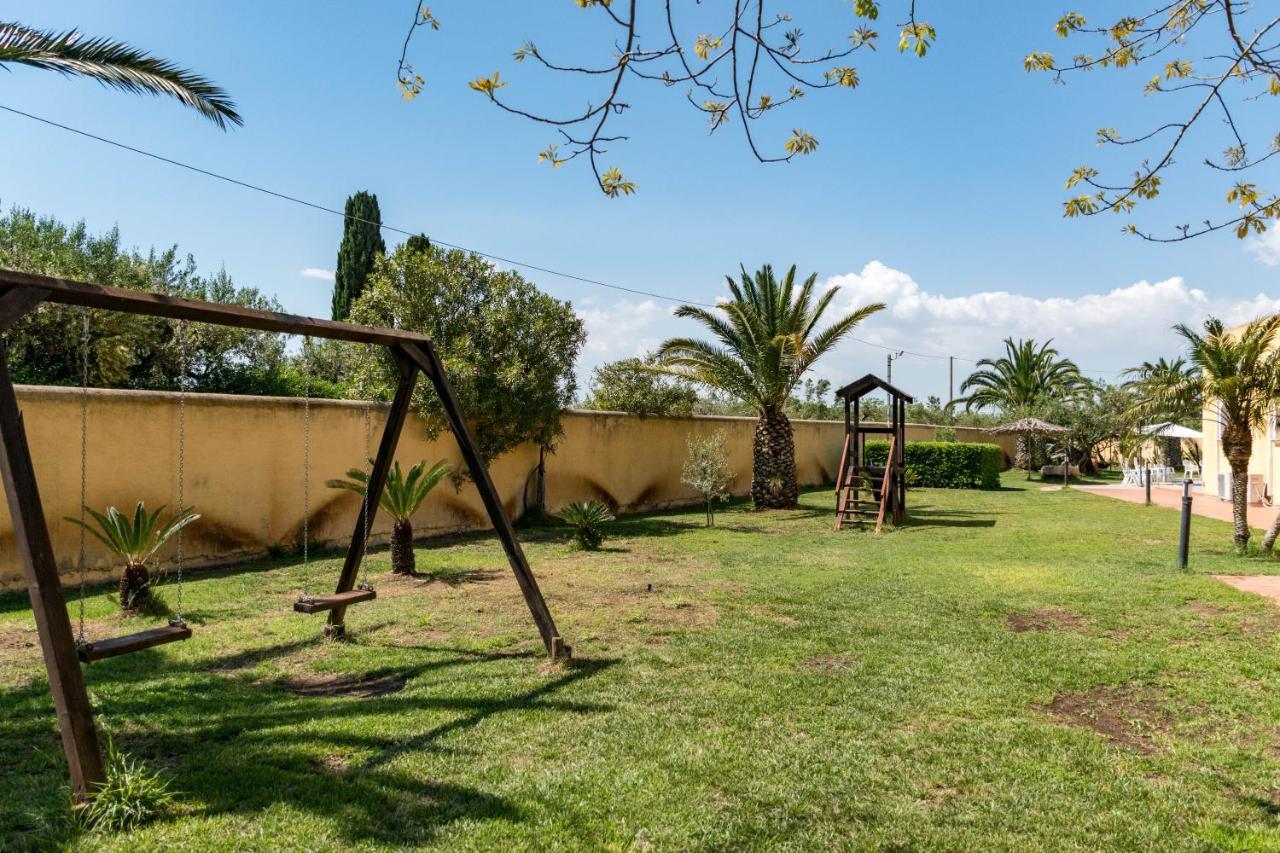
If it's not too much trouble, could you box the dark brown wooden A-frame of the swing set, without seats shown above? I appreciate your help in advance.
[0,270,570,800]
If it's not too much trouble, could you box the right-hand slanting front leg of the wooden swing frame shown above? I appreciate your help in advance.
[404,342,572,658]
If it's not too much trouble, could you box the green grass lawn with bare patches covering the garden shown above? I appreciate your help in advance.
[0,474,1280,850]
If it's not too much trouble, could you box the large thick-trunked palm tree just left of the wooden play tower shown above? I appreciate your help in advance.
[657,265,884,508]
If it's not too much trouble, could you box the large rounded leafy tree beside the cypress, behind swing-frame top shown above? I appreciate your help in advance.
[351,246,586,460]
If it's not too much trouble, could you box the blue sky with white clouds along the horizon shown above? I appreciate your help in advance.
[0,0,1280,396]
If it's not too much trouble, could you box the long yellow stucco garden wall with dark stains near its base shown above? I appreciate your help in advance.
[0,387,1011,588]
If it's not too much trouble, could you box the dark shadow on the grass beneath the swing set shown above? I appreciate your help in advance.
[0,627,618,848]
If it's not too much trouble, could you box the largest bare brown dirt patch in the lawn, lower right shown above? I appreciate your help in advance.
[1032,686,1172,754]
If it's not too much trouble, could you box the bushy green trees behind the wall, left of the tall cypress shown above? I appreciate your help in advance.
[0,207,290,393]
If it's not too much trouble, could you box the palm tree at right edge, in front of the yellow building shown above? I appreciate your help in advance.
[1135,315,1280,553]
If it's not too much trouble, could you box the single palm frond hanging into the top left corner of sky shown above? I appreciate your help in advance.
[0,22,244,131]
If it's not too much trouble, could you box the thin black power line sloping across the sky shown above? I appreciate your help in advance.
[0,104,1141,374]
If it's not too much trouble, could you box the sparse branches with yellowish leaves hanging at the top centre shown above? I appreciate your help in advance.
[398,0,937,197]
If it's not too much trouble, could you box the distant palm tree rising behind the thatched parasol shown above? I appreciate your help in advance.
[951,338,1089,471]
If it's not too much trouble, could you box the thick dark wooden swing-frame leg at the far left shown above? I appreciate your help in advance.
[0,345,106,802]
